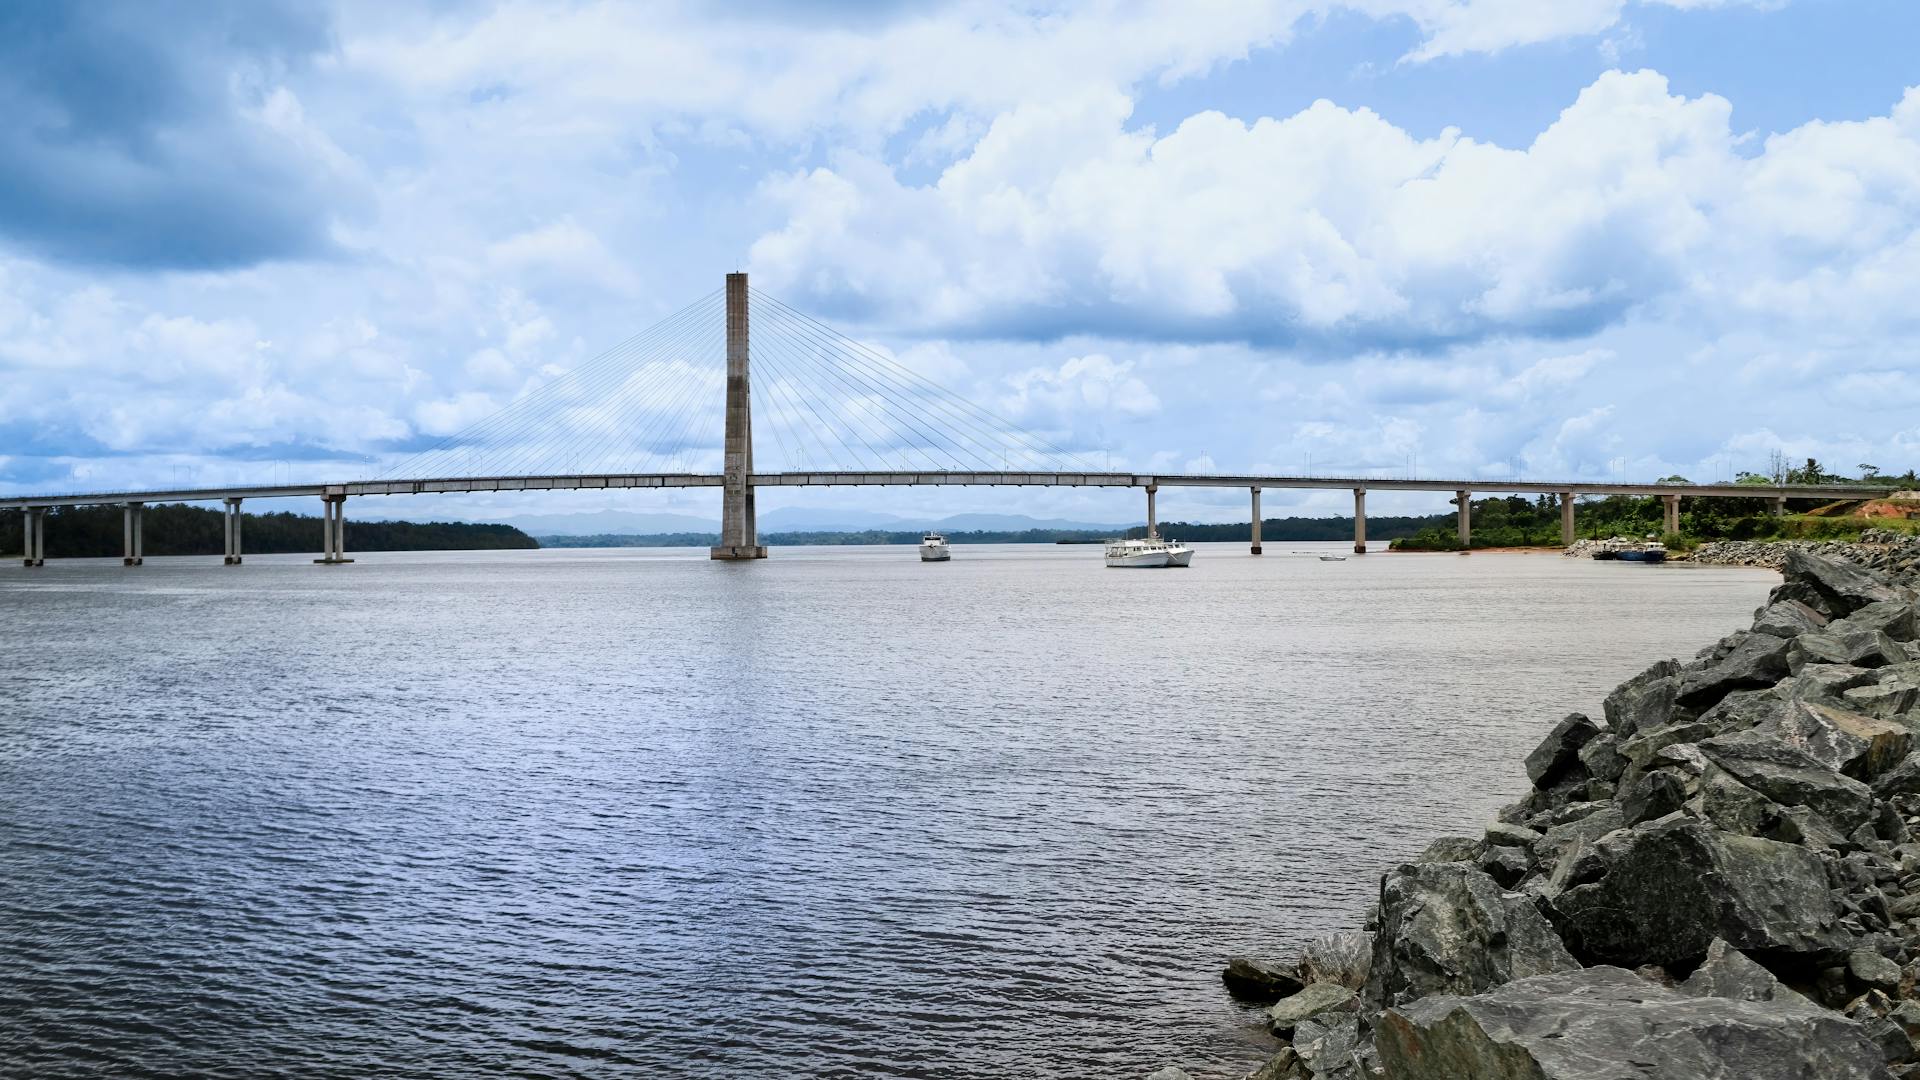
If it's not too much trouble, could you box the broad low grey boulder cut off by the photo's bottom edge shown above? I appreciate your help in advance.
[1375,967,1891,1080]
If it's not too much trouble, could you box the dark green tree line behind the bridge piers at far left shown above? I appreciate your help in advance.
[0,505,540,559]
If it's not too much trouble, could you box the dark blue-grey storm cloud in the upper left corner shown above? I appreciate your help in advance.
[0,0,363,269]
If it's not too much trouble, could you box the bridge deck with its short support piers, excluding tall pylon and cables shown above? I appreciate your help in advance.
[0,471,1887,565]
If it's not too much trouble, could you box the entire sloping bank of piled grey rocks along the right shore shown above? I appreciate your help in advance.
[1154,534,1920,1080]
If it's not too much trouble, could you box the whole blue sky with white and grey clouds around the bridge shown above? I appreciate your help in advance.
[0,0,1920,521]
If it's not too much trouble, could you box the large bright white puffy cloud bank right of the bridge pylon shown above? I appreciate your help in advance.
[753,71,1920,354]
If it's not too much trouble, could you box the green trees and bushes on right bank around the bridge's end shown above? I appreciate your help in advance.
[1394,457,1920,552]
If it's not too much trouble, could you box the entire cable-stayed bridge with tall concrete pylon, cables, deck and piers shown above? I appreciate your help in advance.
[0,273,1884,567]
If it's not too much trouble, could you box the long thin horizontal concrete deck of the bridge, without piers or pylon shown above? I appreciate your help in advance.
[0,471,1887,509]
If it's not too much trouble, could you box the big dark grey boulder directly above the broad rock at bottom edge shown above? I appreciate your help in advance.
[1543,815,1851,967]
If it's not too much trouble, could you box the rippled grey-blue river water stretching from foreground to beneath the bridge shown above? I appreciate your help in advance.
[0,544,1774,1078]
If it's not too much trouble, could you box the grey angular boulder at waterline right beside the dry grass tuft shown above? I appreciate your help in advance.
[1365,863,1580,1007]
